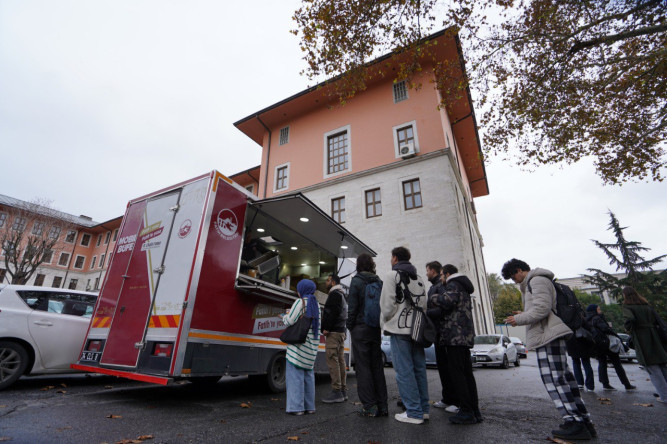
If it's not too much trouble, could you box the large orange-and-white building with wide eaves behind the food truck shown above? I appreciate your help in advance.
[232,31,494,333]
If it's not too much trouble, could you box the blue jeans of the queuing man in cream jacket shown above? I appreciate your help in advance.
[390,335,429,419]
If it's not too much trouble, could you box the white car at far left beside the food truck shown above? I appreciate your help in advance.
[0,285,97,390]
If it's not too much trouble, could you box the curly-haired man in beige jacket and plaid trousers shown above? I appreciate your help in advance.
[502,259,597,440]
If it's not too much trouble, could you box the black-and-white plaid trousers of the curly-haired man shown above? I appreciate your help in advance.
[536,339,589,421]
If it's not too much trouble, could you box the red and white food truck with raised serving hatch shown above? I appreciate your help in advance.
[72,171,375,391]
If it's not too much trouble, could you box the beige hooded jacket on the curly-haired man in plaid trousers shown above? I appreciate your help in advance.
[514,268,572,350]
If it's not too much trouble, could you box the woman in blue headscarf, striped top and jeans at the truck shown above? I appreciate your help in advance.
[283,279,321,415]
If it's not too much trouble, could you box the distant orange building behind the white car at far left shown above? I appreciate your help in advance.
[0,195,122,291]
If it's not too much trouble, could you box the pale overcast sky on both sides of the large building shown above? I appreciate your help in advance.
[0,0,667,278]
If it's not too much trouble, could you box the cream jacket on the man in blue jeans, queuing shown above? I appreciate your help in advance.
[380,261,427,336]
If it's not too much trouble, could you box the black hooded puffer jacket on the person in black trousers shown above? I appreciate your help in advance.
[434,273,475,348]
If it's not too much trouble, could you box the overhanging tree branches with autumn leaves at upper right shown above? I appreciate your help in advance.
[293,0,667,184]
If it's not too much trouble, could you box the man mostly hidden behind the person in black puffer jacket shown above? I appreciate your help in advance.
[426,261,459,413]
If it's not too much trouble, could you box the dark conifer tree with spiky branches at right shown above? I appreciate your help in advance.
[585,211,667,317]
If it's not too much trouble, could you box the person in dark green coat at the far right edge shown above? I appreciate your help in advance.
[623,287,667,403]
